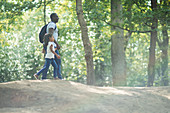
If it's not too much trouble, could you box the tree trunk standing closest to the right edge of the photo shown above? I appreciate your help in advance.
[157,0,169,86]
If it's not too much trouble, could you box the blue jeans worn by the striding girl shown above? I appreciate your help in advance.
[36,58,58,79]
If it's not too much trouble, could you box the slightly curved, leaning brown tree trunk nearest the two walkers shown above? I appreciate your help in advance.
[76,0,95,85]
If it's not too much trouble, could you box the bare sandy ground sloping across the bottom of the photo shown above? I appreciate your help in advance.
[0,80,170,113]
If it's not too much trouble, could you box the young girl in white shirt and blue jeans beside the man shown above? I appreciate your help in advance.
[34,34,60,79]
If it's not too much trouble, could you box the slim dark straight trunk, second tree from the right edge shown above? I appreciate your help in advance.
[147,0,158,87]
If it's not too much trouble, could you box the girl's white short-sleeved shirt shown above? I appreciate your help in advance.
[45,42,55,58]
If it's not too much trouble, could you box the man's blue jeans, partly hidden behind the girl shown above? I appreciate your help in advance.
[42,46,62,79]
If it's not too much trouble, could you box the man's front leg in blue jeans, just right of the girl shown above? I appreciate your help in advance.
[55,50,62,79]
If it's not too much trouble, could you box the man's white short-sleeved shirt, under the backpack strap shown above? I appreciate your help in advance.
[47,22,58,46]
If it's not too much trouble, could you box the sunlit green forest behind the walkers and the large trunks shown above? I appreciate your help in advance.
[0,0,170,86]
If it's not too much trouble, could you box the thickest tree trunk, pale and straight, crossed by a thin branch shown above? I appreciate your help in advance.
[111,0,126,86]
